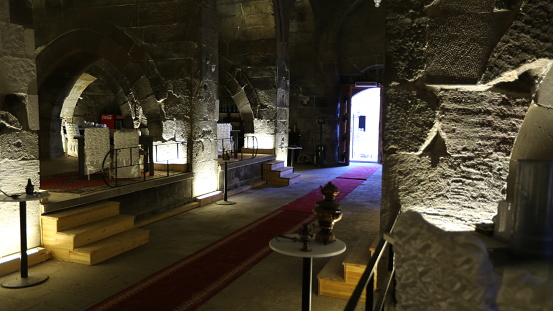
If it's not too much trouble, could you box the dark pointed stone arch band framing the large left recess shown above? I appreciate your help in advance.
[37,29,166,159]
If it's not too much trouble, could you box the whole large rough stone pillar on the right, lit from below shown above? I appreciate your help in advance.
[381,0,536,230]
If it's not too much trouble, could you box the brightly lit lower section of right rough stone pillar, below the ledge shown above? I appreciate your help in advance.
[383,87,530,230]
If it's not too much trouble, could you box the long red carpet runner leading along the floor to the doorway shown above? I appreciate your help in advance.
[88,166,378,311]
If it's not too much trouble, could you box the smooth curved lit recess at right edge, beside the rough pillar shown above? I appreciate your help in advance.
[507,63,553,201]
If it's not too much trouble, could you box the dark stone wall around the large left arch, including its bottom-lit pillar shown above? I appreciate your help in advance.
[34,0,218,194]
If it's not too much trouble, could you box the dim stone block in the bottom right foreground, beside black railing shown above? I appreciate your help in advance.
[390,212,499,311]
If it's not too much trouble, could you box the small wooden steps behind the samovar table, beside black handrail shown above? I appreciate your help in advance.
[317,239,377,301]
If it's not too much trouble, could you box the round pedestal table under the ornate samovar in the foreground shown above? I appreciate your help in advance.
[269,234,346,311]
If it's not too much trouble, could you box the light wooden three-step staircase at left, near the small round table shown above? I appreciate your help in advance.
[41,201,150,265]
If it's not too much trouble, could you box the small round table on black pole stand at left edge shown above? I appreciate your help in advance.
[0,192,50,288]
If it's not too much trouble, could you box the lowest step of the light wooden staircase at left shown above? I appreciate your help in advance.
[67,228,150,265]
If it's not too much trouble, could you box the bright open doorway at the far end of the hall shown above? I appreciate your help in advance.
[349,87,380,162]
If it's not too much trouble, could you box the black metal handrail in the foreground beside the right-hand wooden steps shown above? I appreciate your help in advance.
[344,213,399,311]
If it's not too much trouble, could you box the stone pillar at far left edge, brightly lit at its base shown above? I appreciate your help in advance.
[0,0,41,257]
